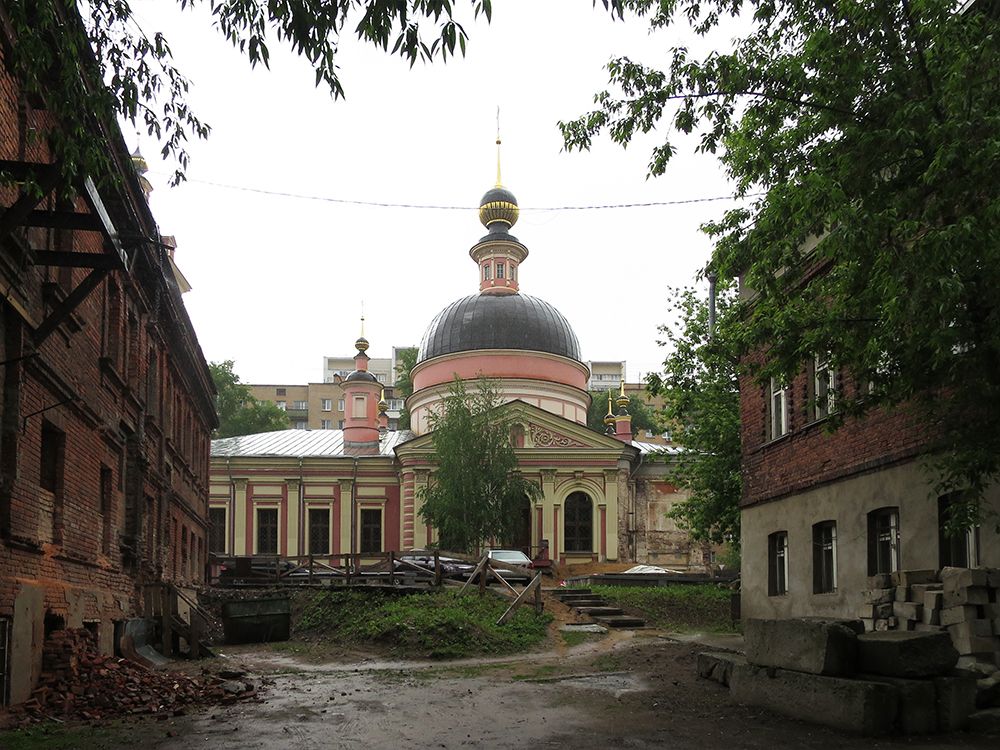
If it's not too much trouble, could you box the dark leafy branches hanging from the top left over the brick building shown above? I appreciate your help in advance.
[0,0,492,187]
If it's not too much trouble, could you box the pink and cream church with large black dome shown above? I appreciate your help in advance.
[209,160,709,569]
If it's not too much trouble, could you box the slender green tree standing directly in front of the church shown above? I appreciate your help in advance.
[420,378,539,552]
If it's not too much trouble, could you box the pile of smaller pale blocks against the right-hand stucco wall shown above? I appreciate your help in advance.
[858,568,1000,663]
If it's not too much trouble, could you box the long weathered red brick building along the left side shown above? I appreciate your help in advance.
[0,11,216,704]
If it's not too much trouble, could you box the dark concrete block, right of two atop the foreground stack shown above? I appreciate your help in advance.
[858,630,958,677]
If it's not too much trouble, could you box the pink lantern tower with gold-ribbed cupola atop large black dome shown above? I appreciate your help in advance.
[469,136,528,294]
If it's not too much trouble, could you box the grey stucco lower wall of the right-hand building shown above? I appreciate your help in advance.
[742,462,1000,618]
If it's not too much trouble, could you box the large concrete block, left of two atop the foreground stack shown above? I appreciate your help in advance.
[743,618,864,675]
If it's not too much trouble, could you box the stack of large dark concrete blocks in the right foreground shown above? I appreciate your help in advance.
[698,618,1000,735]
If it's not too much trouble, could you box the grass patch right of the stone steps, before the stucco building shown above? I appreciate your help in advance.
[593,584,737,633]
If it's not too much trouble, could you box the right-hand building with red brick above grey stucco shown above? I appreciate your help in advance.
[740,340,1000,618]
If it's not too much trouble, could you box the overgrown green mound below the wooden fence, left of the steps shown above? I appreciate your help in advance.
[295,590,552,659]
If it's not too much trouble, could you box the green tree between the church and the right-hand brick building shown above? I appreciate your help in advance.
[649,288,742,550]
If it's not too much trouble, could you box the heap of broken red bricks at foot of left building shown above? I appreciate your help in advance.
[13,629,257,724]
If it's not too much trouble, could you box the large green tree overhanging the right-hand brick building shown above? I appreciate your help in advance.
[561,0,1000,523]
